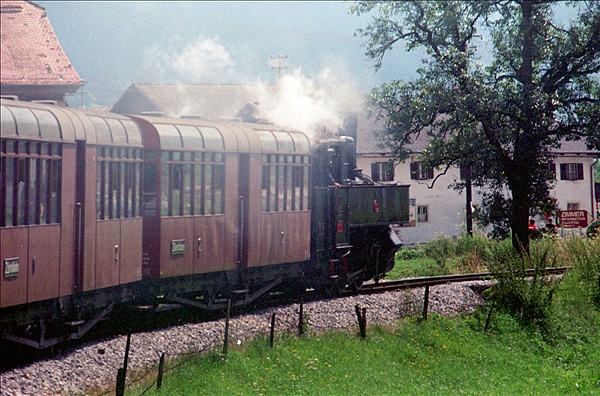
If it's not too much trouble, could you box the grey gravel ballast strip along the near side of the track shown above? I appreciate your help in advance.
[0,281,486,396]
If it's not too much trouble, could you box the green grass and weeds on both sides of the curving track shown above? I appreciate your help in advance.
[127,239,600,395]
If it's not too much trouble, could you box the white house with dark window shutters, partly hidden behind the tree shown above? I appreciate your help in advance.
[357,128,600,244]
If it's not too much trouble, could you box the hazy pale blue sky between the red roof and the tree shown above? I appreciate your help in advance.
[38,1,420,106]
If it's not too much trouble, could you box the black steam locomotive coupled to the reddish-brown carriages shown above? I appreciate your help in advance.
[311,136,409,290]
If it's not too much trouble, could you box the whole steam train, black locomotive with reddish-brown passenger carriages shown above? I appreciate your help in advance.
[0,100,409,348]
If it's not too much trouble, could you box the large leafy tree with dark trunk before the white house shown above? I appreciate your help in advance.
[351,0,600,251]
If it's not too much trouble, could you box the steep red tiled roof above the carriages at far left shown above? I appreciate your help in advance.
[0,0,83,87]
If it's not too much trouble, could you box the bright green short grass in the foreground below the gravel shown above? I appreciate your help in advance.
[127,315,600,395]
